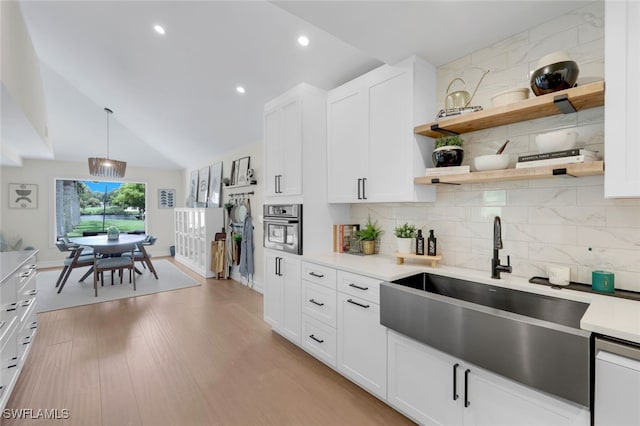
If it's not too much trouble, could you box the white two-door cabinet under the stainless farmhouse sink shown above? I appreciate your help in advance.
[388,331,590,426]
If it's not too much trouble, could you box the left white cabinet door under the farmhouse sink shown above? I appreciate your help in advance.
[387,330,464,426]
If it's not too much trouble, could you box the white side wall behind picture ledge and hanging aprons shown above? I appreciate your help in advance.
[178,140,264,293]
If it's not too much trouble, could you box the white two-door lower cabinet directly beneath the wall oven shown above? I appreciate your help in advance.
[264,249,301,345]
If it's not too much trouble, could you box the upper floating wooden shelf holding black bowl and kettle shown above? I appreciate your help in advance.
[414,81,604,138]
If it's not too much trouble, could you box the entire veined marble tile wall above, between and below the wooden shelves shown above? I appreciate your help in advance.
[351,2,640,291]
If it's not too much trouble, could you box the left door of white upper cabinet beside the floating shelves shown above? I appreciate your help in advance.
[327,85,369,203]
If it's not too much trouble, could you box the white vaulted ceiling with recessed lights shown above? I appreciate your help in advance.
[2,0,589,169]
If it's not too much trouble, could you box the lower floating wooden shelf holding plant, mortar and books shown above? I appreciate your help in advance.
[414,161,604,185]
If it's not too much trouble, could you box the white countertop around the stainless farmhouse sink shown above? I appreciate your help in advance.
[302,253,640,344]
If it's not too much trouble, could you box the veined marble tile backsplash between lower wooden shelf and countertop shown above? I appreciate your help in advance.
[351,177,640,291]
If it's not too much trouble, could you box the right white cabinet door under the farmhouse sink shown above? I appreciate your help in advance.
[463,367,591,426]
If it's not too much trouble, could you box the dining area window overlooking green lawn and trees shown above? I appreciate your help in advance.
[55,179,147,237]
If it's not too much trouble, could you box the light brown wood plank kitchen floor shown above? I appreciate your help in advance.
[0,259,411,426]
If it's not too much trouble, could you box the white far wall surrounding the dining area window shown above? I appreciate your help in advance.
[0,160,185,267]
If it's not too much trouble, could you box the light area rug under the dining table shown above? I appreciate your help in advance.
[37,259,200,312]
